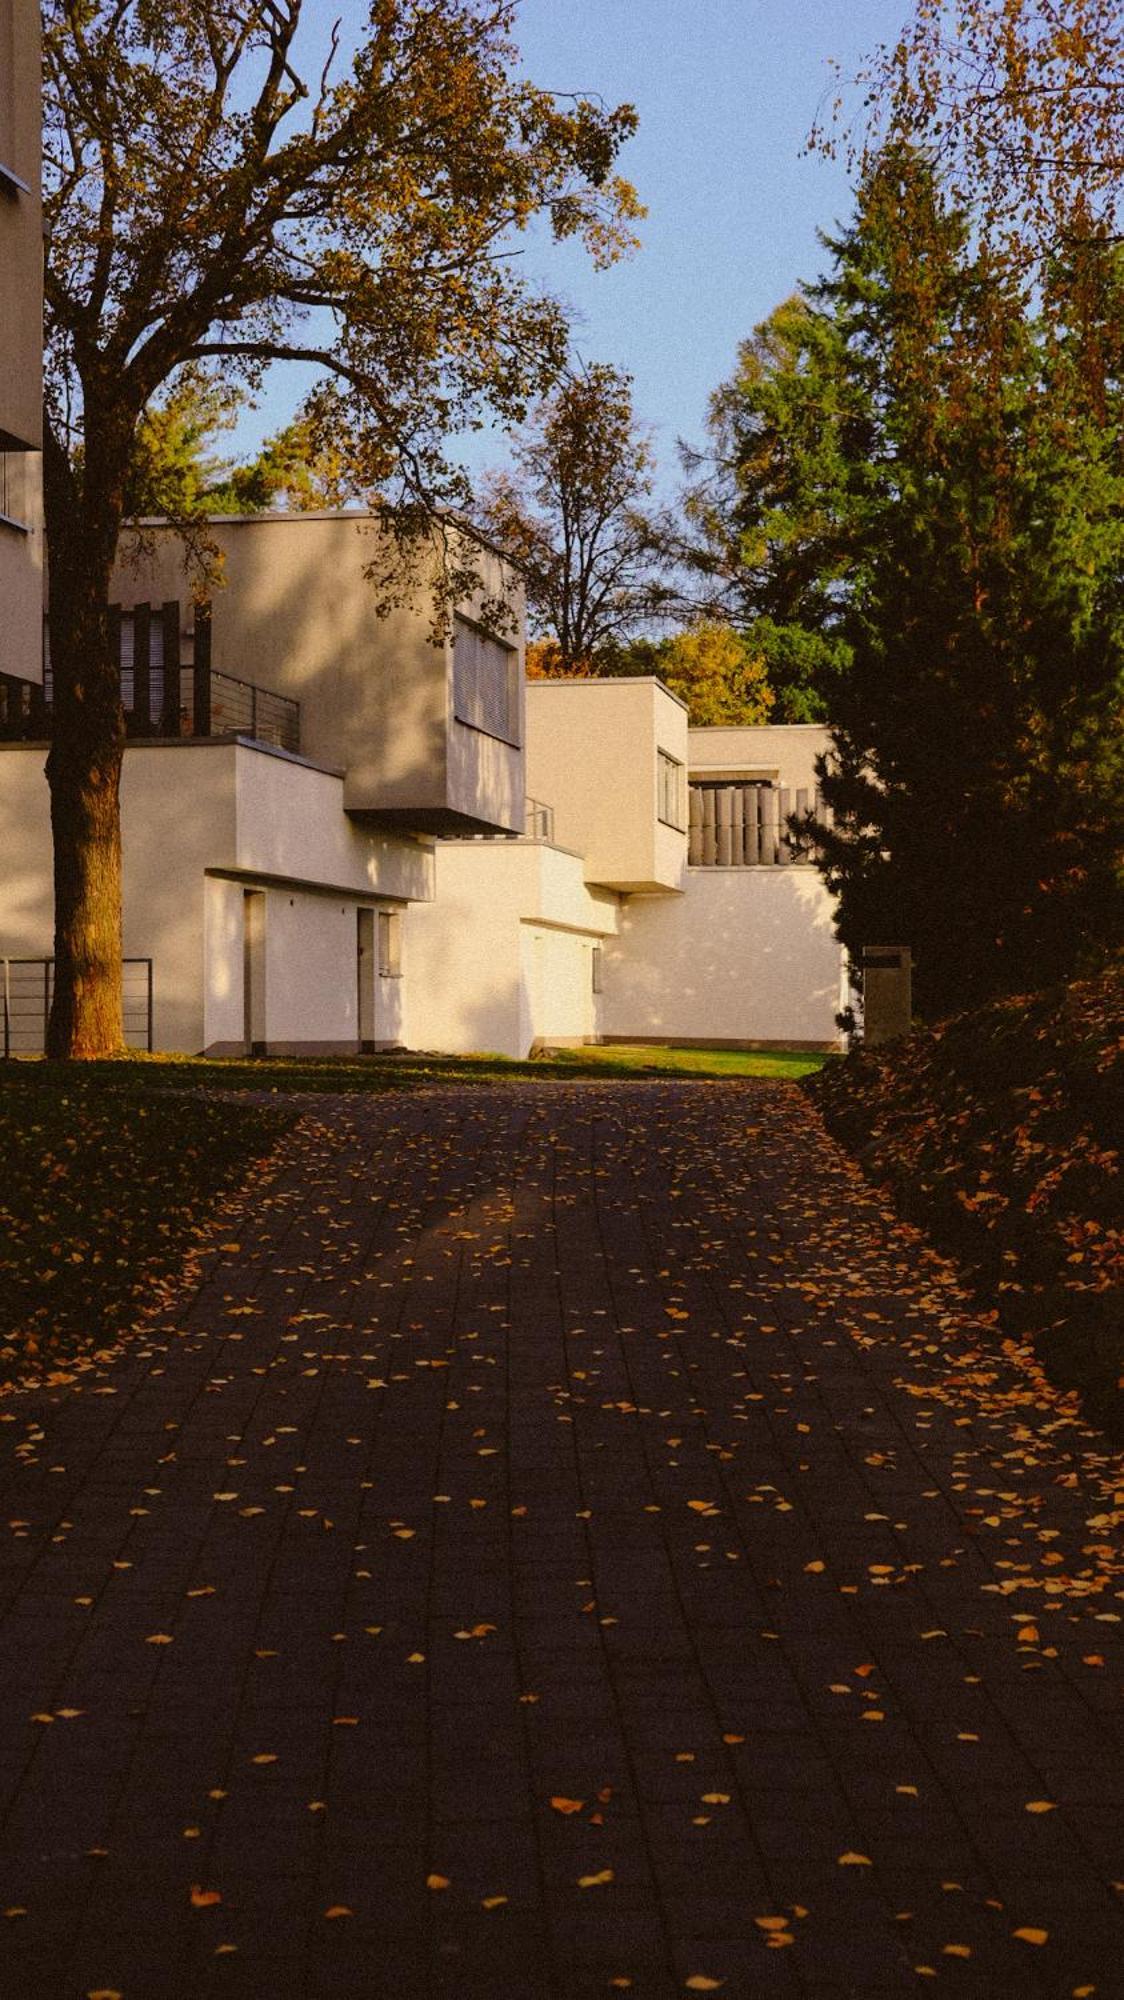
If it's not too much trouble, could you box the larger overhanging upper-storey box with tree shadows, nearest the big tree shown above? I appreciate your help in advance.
[114,510,526,834]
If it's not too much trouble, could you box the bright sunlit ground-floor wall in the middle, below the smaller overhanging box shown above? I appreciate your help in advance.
[406,842,618,1056]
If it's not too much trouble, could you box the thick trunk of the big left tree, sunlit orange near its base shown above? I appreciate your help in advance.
[44,410,132,1058]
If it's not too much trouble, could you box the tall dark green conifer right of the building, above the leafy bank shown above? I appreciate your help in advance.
[788,148,1124,1014]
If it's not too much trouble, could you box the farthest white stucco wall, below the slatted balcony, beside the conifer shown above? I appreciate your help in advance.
[602,868,844,1046]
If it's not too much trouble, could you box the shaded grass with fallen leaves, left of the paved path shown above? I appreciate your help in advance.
[0,1064,294,1384]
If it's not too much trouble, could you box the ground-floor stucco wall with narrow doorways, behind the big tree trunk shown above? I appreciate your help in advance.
[0,742,434,1052]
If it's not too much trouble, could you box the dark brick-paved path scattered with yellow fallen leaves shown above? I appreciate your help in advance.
[0,1084,1124,2000]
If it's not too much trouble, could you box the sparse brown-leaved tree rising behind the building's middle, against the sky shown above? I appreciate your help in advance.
[478,362,670,674]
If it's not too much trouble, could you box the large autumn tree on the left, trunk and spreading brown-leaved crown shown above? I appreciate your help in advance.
[44,0,638,1056]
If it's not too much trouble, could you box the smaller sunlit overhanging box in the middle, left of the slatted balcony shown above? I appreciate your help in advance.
[526,676,688,894]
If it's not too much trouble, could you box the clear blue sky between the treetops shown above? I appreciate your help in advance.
[236,0,912,490]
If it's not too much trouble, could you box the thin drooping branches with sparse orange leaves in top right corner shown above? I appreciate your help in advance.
[812,0,1124,266]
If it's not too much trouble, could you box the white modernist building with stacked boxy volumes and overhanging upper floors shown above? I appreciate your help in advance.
[0,512,846,1056]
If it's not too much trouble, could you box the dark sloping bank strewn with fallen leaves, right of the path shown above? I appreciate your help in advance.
[808,966,1124,1436]
